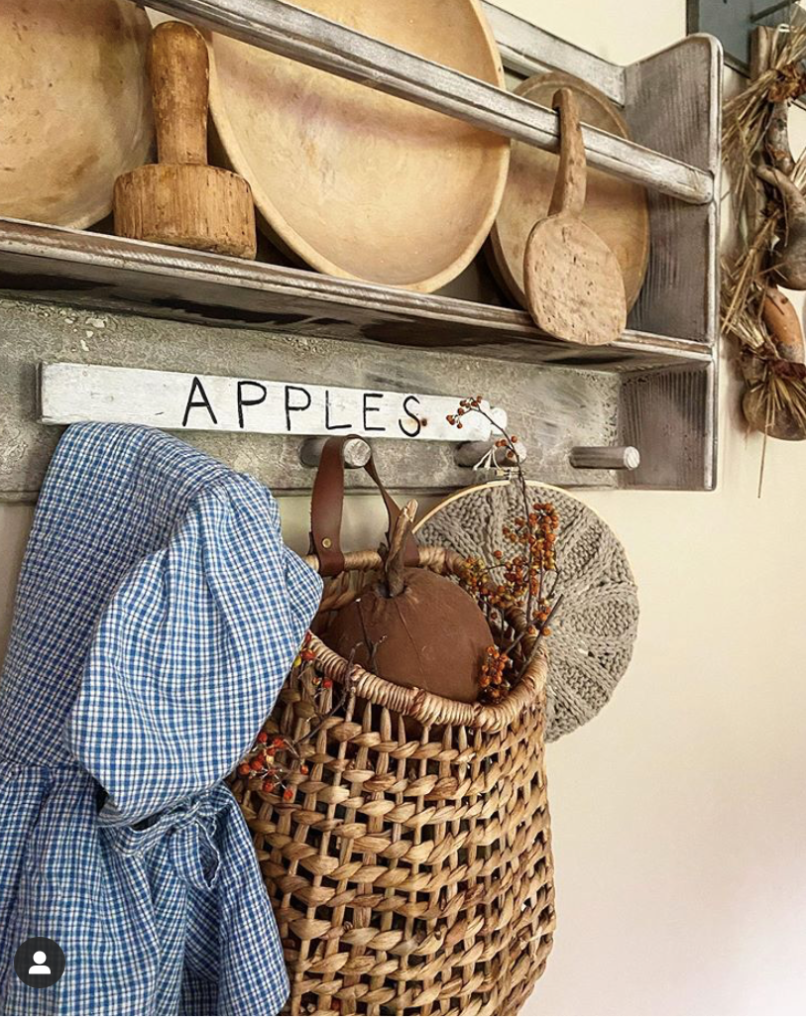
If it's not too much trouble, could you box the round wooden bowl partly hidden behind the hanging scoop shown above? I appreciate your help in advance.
[490,72,649,309]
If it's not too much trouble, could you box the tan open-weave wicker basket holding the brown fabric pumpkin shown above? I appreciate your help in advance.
[234,548,554,1017]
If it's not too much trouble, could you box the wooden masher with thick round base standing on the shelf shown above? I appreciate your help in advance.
[115,22,257,259]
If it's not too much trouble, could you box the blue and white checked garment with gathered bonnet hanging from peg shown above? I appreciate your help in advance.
[0,424,321,1016]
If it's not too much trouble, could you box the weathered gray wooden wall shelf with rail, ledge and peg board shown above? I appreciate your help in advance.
[0,0,721,498]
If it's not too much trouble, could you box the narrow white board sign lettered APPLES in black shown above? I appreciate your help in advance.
[40,362,497,442]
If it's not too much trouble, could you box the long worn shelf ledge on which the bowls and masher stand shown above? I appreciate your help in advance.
[0,220,711,369]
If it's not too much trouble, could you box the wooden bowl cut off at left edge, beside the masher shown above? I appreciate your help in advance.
[0,0,153,227]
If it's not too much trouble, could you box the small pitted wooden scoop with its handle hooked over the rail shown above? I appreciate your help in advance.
[523,88,627,345]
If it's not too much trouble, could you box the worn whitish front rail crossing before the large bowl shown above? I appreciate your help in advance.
[143,0,714,204]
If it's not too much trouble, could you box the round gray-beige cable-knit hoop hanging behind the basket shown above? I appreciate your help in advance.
[417,482,638,740]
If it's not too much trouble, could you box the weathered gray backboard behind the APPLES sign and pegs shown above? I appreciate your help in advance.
[0,299,620,501]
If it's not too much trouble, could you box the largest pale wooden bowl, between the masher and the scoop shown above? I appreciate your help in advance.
[210,0,509,292]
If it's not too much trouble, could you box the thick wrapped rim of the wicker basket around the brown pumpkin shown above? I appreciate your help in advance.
[305,547,548,732]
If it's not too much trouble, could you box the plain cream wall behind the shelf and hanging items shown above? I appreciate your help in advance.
[0,0,806,1015]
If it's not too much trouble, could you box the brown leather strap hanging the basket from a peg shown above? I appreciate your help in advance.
[310,434,420,577]
